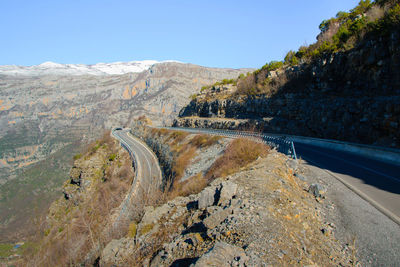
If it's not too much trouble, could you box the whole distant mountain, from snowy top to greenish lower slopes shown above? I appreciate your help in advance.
[0,61,247,243]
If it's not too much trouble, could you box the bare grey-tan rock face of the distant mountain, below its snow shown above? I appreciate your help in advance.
[0,62,250,183]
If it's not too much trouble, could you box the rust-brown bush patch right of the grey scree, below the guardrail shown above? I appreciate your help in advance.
[205,138,270,181]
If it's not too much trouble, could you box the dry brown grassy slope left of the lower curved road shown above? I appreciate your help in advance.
[27,133,134,266]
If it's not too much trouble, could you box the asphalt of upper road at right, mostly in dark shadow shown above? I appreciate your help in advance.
[295,142,400,223]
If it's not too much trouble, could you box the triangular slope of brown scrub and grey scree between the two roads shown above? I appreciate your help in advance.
[141,128,269,199]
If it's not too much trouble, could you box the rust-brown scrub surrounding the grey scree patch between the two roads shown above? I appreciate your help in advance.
[147,128,270,200]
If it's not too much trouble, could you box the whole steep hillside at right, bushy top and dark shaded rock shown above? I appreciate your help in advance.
[175,1,400,147]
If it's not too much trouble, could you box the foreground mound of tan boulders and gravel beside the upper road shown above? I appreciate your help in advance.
[100,151,351,266]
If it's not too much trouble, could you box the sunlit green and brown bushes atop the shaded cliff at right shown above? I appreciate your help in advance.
[197,0,400,100]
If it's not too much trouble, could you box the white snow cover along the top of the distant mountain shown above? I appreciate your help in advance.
[0,60,178,76]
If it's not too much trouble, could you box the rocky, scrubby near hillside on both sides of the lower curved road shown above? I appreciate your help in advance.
[15,128,358,266]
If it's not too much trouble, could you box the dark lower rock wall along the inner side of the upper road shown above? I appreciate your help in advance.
[174,96,400,147]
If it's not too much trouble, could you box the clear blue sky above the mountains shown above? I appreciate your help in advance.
[0,0,359,68]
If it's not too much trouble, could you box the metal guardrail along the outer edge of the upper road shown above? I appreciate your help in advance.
[160,127,297,160]
